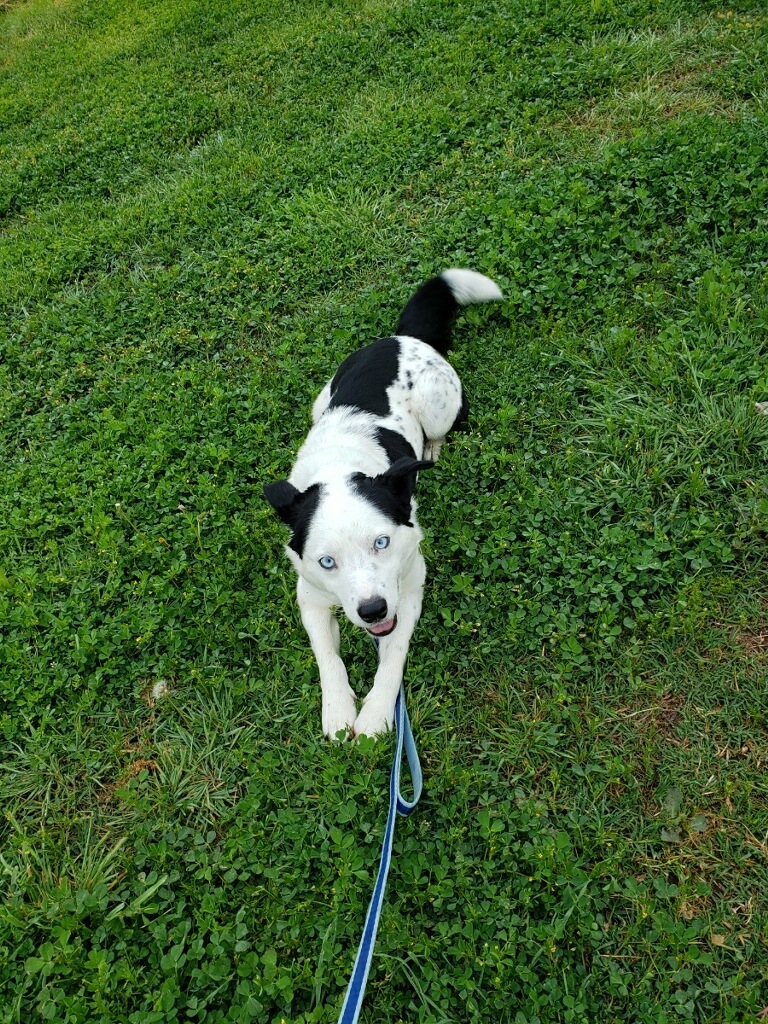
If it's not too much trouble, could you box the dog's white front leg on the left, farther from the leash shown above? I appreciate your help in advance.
[298,581,357,739]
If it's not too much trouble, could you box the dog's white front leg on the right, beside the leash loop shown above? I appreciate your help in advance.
[353,553,426,736]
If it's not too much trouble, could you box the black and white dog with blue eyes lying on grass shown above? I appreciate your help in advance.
[264,269,502,738]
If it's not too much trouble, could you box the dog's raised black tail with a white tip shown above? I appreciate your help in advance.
[396,268,504,355]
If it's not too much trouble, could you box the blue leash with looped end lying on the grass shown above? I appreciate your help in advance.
[339,686,422,1024]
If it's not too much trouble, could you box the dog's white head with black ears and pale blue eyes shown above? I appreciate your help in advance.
[264,458,433,637]
